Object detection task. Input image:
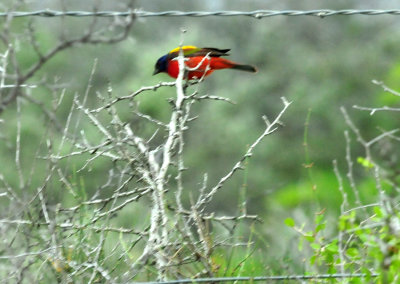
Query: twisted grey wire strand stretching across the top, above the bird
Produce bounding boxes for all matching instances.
[0,9,400,19]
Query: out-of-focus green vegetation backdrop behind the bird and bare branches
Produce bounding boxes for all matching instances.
[0,0,400,276]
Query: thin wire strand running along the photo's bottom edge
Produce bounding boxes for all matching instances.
[135,273,378,284]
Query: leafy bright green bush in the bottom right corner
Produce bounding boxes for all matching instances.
[285,202,400,283]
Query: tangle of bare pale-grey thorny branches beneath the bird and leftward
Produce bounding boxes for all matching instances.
[0,10,290,283]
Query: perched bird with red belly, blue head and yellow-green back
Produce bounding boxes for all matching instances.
[153,45,257,80]
